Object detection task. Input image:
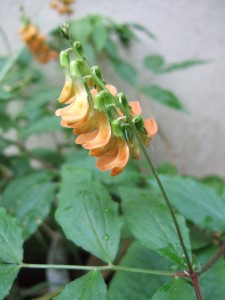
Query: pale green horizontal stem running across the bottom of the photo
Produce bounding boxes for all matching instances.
[19,263,174,276]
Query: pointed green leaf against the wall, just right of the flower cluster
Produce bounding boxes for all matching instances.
[141,85,184,111]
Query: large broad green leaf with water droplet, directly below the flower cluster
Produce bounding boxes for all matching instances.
[56,166,122,262]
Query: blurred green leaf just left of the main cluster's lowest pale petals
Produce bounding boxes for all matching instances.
[20,116,61,138]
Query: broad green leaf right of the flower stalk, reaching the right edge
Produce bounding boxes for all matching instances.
[150,176,225,232]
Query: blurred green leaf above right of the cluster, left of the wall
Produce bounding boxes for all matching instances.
[110,57,137,85]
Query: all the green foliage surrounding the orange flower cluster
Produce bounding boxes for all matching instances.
[0,6,221,300]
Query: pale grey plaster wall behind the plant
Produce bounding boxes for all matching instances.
[0,0,225,176]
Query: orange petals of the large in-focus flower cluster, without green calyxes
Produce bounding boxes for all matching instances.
[56,69,157,176]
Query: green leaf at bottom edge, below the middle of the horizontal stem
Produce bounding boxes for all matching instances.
[53,271,107,300]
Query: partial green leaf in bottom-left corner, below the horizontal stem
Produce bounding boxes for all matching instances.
[0,263,19,299]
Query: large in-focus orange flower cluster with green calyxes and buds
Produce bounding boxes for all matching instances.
[56,44,157,176]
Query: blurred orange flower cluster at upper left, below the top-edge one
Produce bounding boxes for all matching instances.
[19,22,58,63]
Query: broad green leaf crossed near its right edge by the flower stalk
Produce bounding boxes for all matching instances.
[120,188,191,266]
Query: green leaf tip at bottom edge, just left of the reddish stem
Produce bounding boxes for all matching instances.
[151,278,195,300]
